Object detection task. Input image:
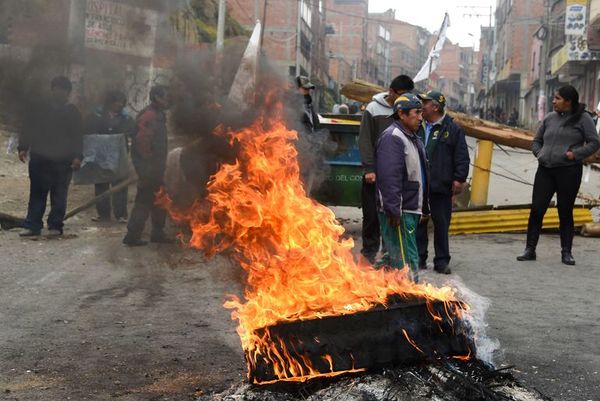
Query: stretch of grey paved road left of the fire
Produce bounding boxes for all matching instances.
[0,224,245,401]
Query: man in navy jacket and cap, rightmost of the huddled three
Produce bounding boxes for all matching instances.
[417,90,470,274]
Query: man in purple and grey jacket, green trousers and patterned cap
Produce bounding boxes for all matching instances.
[375,93,429,282]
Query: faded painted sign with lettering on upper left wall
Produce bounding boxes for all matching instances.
[85,0,158,58]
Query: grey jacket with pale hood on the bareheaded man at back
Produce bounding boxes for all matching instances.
[358,92,394,173]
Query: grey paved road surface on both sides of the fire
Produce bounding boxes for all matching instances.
[0,133,600,401]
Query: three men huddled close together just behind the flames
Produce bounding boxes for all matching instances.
[359,75,470,281]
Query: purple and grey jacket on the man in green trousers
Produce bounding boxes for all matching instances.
[375,120,429,217]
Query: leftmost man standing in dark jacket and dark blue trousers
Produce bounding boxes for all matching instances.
[18,77,82,237]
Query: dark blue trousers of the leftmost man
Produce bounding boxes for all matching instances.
[25,156,73,232]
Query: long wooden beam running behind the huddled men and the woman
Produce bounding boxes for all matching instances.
[340,80,600,163]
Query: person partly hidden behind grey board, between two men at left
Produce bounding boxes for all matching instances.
[84,90,134,223]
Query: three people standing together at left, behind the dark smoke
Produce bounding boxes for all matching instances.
[18,76,173,246]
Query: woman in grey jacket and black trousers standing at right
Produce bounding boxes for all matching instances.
[517,85,600,265]
